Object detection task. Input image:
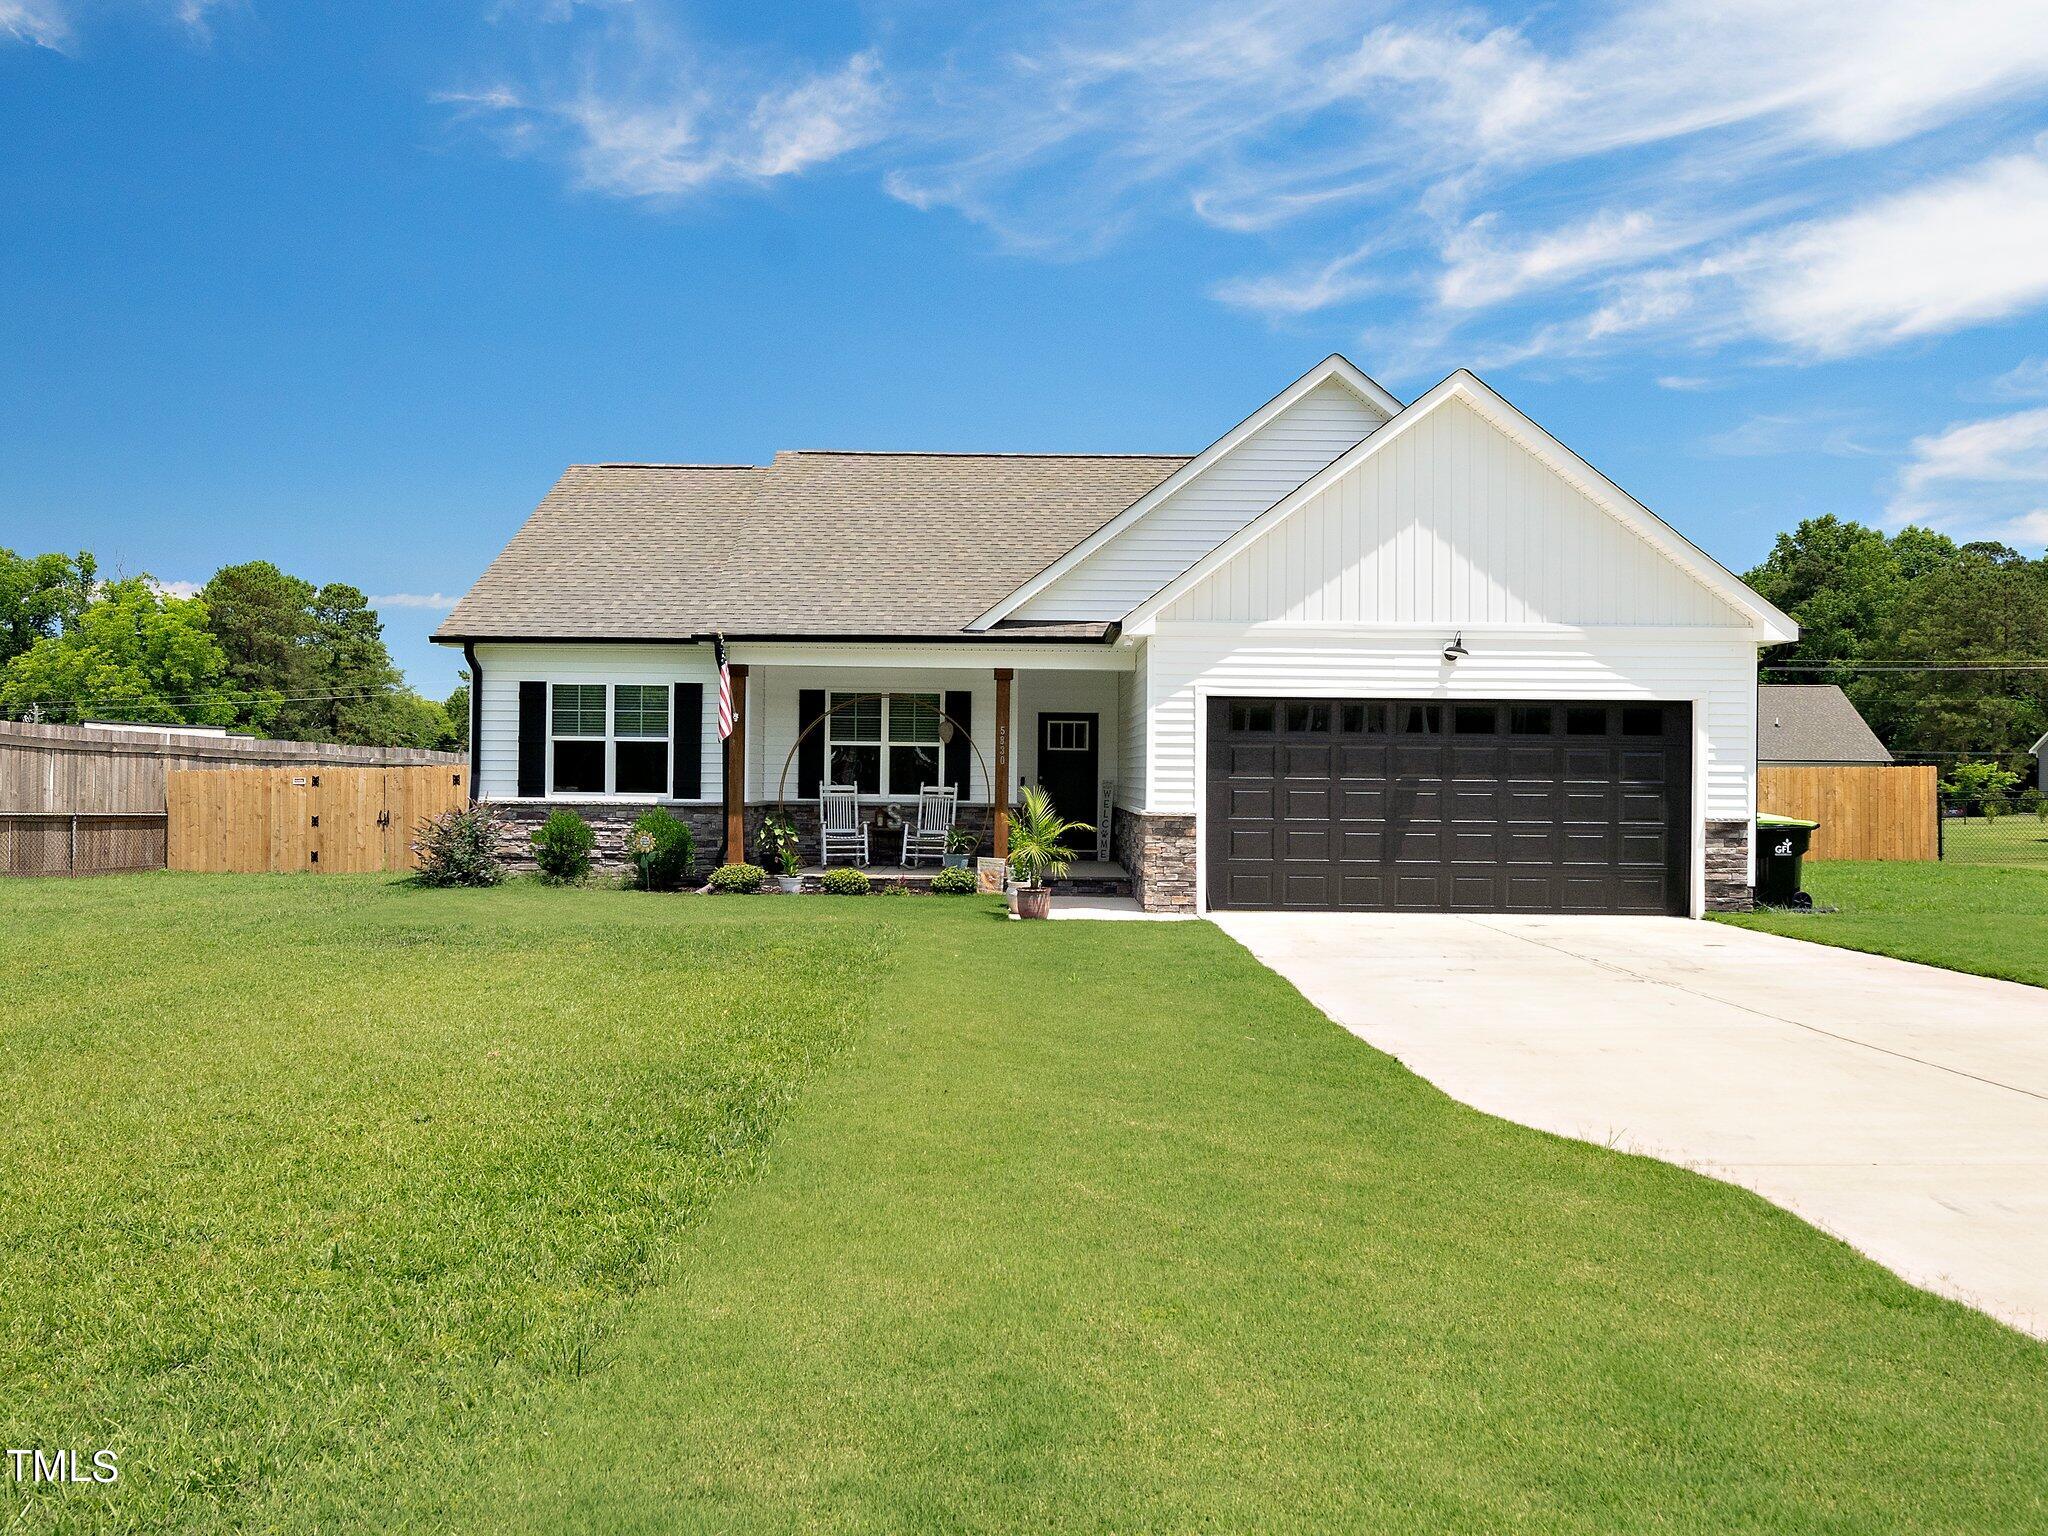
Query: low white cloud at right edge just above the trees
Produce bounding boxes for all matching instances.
[1886,408,2048,547]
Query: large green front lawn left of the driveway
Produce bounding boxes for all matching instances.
[0,877,2048,1534]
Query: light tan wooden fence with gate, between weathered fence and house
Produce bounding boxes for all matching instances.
[166,768,469,874]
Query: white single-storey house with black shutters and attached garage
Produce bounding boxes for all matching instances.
[436,356,1798,913]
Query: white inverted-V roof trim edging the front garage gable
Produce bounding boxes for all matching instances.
[1124,369,1798,643]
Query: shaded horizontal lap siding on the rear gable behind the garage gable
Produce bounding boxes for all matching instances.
[1014,381,1386,623]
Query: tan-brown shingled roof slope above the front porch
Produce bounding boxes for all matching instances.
[436,451,1188,641]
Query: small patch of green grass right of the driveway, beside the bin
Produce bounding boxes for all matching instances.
[1720,860,2048,987]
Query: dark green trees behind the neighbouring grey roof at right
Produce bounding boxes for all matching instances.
[1745,516,2048,778]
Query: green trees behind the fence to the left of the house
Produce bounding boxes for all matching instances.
[0,549,469,748]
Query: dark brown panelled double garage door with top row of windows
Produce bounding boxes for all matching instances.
[1206,698,1692,913]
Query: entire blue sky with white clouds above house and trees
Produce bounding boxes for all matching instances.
[0,0,2048,692]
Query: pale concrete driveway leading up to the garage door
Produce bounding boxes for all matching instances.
[1217,913,2048,1337]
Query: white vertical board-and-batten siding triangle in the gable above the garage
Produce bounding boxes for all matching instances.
[1161,401,1747,639]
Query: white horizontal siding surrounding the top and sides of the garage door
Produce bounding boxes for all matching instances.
[1145,629,1757,825]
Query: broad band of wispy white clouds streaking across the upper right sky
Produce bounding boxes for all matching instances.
[452,0,2048,362]
